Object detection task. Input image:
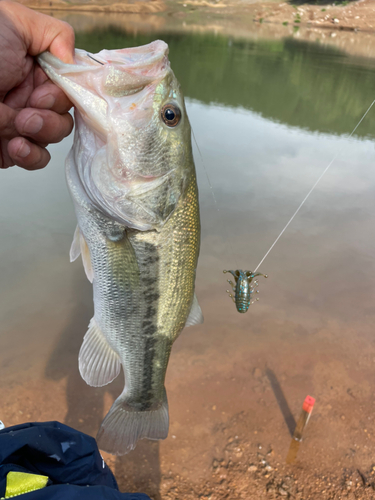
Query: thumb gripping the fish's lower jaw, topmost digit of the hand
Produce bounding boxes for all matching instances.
[1,0,74,64]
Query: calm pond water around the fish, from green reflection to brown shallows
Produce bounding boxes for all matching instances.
[0,16,375,499]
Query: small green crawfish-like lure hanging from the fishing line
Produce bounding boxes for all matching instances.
[223,269,267,313]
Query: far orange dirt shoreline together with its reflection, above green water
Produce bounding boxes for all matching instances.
[17,0,375,58]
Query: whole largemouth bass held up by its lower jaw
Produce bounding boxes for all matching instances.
[39,41,203,455]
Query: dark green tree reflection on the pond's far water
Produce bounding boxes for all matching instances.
[76,28,375,137]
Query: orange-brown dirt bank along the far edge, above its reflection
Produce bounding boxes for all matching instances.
[21,0,375,31]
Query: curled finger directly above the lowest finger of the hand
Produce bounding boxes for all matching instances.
[15,108,73,144]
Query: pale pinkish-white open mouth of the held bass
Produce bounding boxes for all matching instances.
[38,40,170,133]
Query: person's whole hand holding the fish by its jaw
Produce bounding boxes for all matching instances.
[0,0,74,170]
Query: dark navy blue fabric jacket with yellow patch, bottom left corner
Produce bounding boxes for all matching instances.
[0,422,150,500]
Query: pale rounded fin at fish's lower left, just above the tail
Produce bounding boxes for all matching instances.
[78,318,121,387]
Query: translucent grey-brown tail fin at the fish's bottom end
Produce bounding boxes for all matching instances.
[96,389,169,455]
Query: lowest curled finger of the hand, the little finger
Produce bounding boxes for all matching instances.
[8,137,51,170]
